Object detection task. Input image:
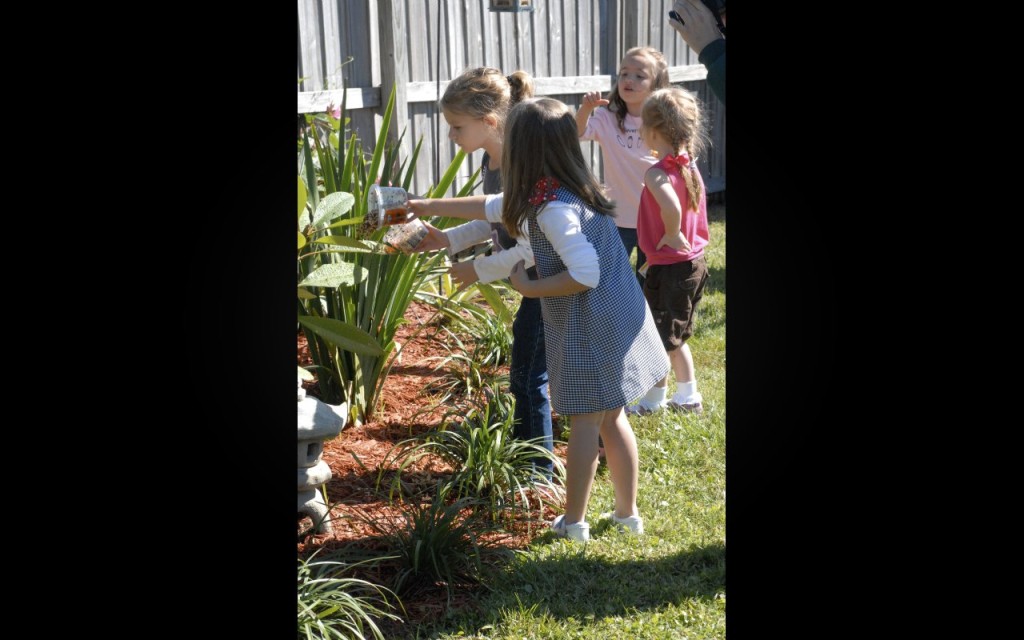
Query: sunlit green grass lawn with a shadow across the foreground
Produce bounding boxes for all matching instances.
[415,205,725,640]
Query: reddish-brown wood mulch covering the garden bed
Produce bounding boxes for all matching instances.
[297,301,565,625]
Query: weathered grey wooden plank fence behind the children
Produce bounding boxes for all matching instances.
[298,0,725,194]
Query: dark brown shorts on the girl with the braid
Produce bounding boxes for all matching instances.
[643,256,708,351]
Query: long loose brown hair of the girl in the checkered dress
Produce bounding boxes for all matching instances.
[502,97,615,237]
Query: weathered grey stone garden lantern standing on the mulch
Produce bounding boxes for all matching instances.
[298,378,348,534]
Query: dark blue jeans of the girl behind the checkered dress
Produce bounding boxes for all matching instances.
[509,298,554,477]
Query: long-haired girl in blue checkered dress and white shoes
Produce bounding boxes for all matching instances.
[503,98,669,541]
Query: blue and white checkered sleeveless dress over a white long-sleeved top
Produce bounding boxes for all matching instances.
[529,187,670,416]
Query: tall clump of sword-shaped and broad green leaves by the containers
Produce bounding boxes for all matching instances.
[298,80,475,420]
